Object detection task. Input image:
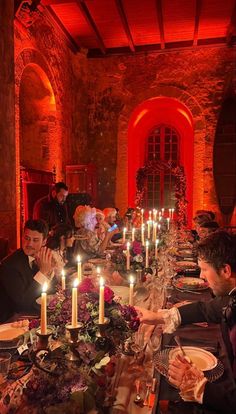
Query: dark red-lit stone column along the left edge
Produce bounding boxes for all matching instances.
[0,0,16,247]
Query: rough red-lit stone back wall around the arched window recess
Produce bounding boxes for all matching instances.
[88,47,236,223]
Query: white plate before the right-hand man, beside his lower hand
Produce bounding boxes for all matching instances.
[169,346,217,371]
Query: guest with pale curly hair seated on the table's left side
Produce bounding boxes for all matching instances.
[73,206,117,255]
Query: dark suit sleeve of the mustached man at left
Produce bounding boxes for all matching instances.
[0,264,41,312]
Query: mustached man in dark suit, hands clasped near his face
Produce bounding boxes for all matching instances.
[0,220,53,322]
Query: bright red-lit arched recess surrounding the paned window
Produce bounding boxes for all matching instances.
[128,97,193,221]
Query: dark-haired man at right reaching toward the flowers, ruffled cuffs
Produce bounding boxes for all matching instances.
[137,231,236,413]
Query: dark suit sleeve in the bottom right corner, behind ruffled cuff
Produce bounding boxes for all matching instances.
[203,382,236,414]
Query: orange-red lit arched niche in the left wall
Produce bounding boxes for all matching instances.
[19,63,62,226]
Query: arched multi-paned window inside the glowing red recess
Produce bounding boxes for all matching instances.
[145,125,180,208]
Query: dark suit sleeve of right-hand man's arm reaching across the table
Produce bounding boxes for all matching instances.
[179,296,229,325]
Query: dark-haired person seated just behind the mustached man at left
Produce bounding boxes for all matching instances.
[46,224,75,276]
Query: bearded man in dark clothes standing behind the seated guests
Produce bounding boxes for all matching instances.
[33,181,70,230]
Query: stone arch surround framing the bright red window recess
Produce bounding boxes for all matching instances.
[116,86,206,223]
